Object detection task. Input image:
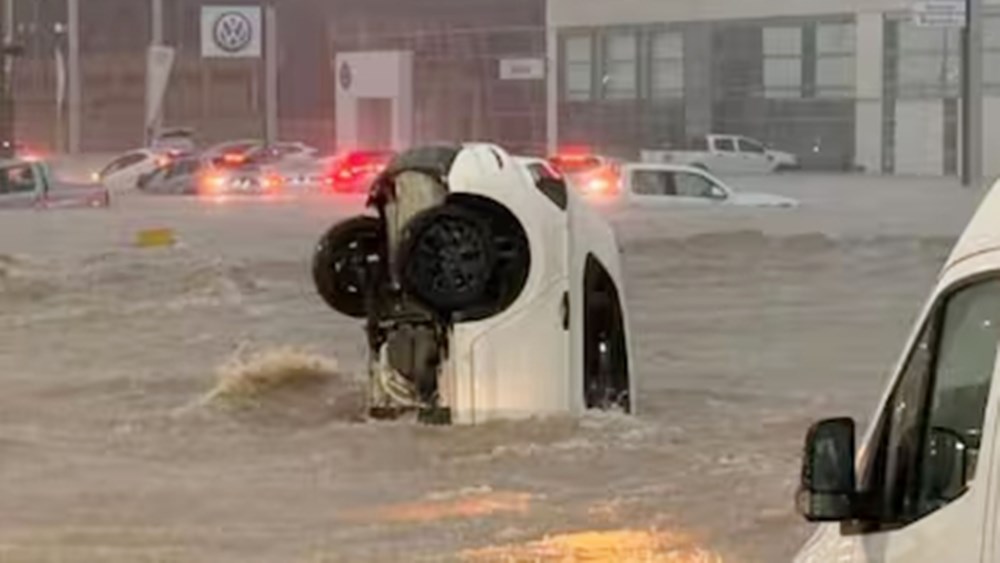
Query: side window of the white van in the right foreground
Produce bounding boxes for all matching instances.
[861,279,1000,528]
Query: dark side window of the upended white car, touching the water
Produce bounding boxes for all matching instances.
[583,254,632,412]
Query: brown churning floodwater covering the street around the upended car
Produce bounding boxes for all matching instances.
[0,175,980,563]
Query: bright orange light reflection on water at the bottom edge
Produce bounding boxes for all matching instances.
[462,530,723,563]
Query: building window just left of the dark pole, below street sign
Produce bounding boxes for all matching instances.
[896,22,960,98]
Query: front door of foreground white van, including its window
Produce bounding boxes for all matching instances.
[828,274,1000,563]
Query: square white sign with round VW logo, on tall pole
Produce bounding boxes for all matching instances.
[201,6,263,58]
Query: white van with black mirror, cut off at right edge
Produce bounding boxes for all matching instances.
[796,186,1000,563]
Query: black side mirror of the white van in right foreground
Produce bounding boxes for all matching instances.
[796,418,857,522]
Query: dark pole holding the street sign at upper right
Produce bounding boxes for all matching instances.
[962,0,983,186]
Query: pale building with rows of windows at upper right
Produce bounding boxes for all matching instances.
[546,0,1000,175]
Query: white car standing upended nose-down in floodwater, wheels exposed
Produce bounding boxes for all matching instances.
[313,144,635,424]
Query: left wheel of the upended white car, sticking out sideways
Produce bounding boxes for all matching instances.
[312,216,382,318]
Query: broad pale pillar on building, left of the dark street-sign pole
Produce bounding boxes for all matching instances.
[854,12,884,173]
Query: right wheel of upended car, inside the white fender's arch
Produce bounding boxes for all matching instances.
[397,204,497,316]
